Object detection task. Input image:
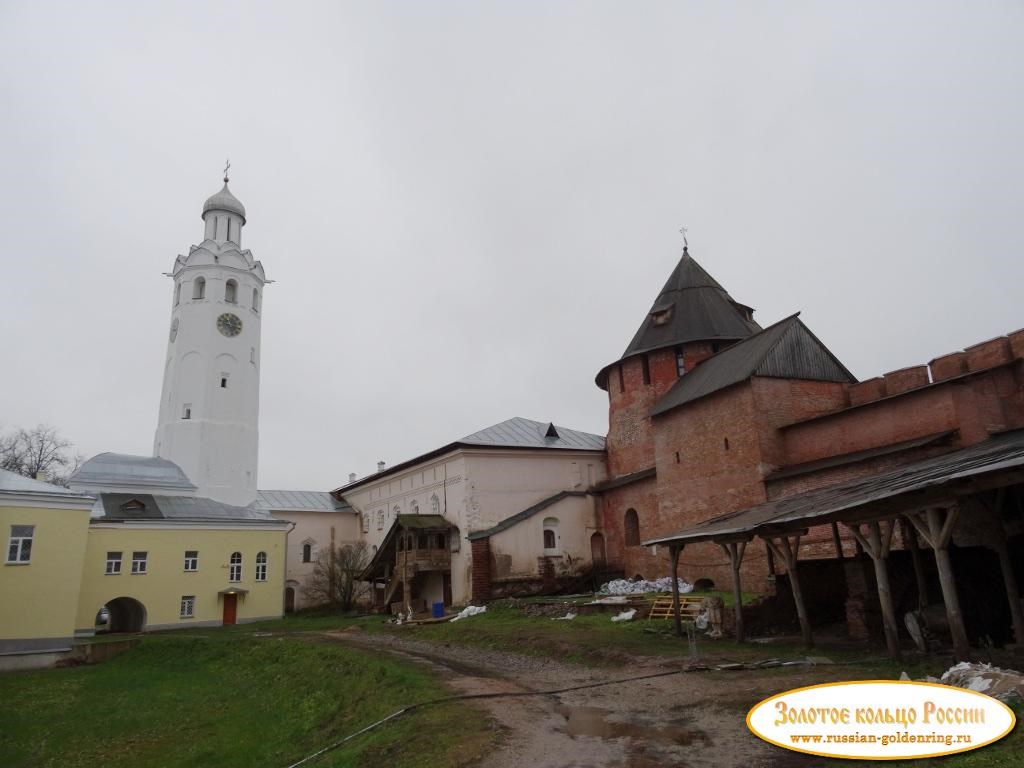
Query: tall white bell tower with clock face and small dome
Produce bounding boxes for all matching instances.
[154,174,267,506]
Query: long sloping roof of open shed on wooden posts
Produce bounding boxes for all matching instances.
[644,429,1024,545]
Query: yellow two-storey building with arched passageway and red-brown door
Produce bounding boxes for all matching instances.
[75,494,289,636]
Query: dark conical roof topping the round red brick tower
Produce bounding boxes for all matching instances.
[596,248,761,389]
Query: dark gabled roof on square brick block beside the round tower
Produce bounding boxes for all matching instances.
[651,314,856,416]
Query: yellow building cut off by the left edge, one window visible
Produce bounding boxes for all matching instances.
[0,470,94,669]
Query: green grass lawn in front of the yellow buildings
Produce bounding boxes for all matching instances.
[0,623,493,768]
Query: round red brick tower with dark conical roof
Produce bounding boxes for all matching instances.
[596,248,761,575]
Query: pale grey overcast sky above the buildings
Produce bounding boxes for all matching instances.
[0,0,1024,488]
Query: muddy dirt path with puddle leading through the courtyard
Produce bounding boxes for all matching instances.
[329,632,822,768]
